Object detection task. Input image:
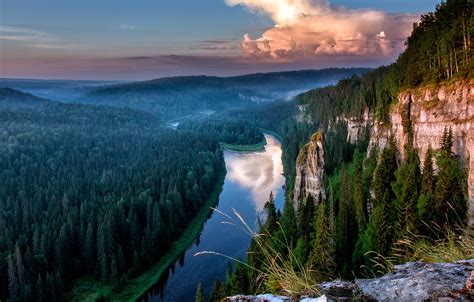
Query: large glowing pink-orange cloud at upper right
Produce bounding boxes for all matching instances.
[226,0,418,61]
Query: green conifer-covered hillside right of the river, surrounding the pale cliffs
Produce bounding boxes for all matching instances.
[220,0,474,296]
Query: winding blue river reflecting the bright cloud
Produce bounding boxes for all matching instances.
[144,134,285,302]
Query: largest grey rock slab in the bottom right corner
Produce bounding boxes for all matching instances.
[356,260,474,302]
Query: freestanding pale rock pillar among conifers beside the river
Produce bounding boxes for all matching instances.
[294,132,326,203]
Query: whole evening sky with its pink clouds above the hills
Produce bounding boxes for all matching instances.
[0,0,439,80]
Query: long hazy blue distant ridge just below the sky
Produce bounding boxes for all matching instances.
[76,68,368,119]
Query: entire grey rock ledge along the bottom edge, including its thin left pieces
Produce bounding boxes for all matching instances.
[225,259,474,302]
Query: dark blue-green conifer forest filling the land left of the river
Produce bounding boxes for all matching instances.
[0,89,230,301]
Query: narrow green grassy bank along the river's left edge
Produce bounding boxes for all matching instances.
[67,171,226,301]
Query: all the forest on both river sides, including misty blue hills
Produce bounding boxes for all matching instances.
[0,0,474,302]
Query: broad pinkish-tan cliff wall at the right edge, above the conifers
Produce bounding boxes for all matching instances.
[344,80,474,225]
